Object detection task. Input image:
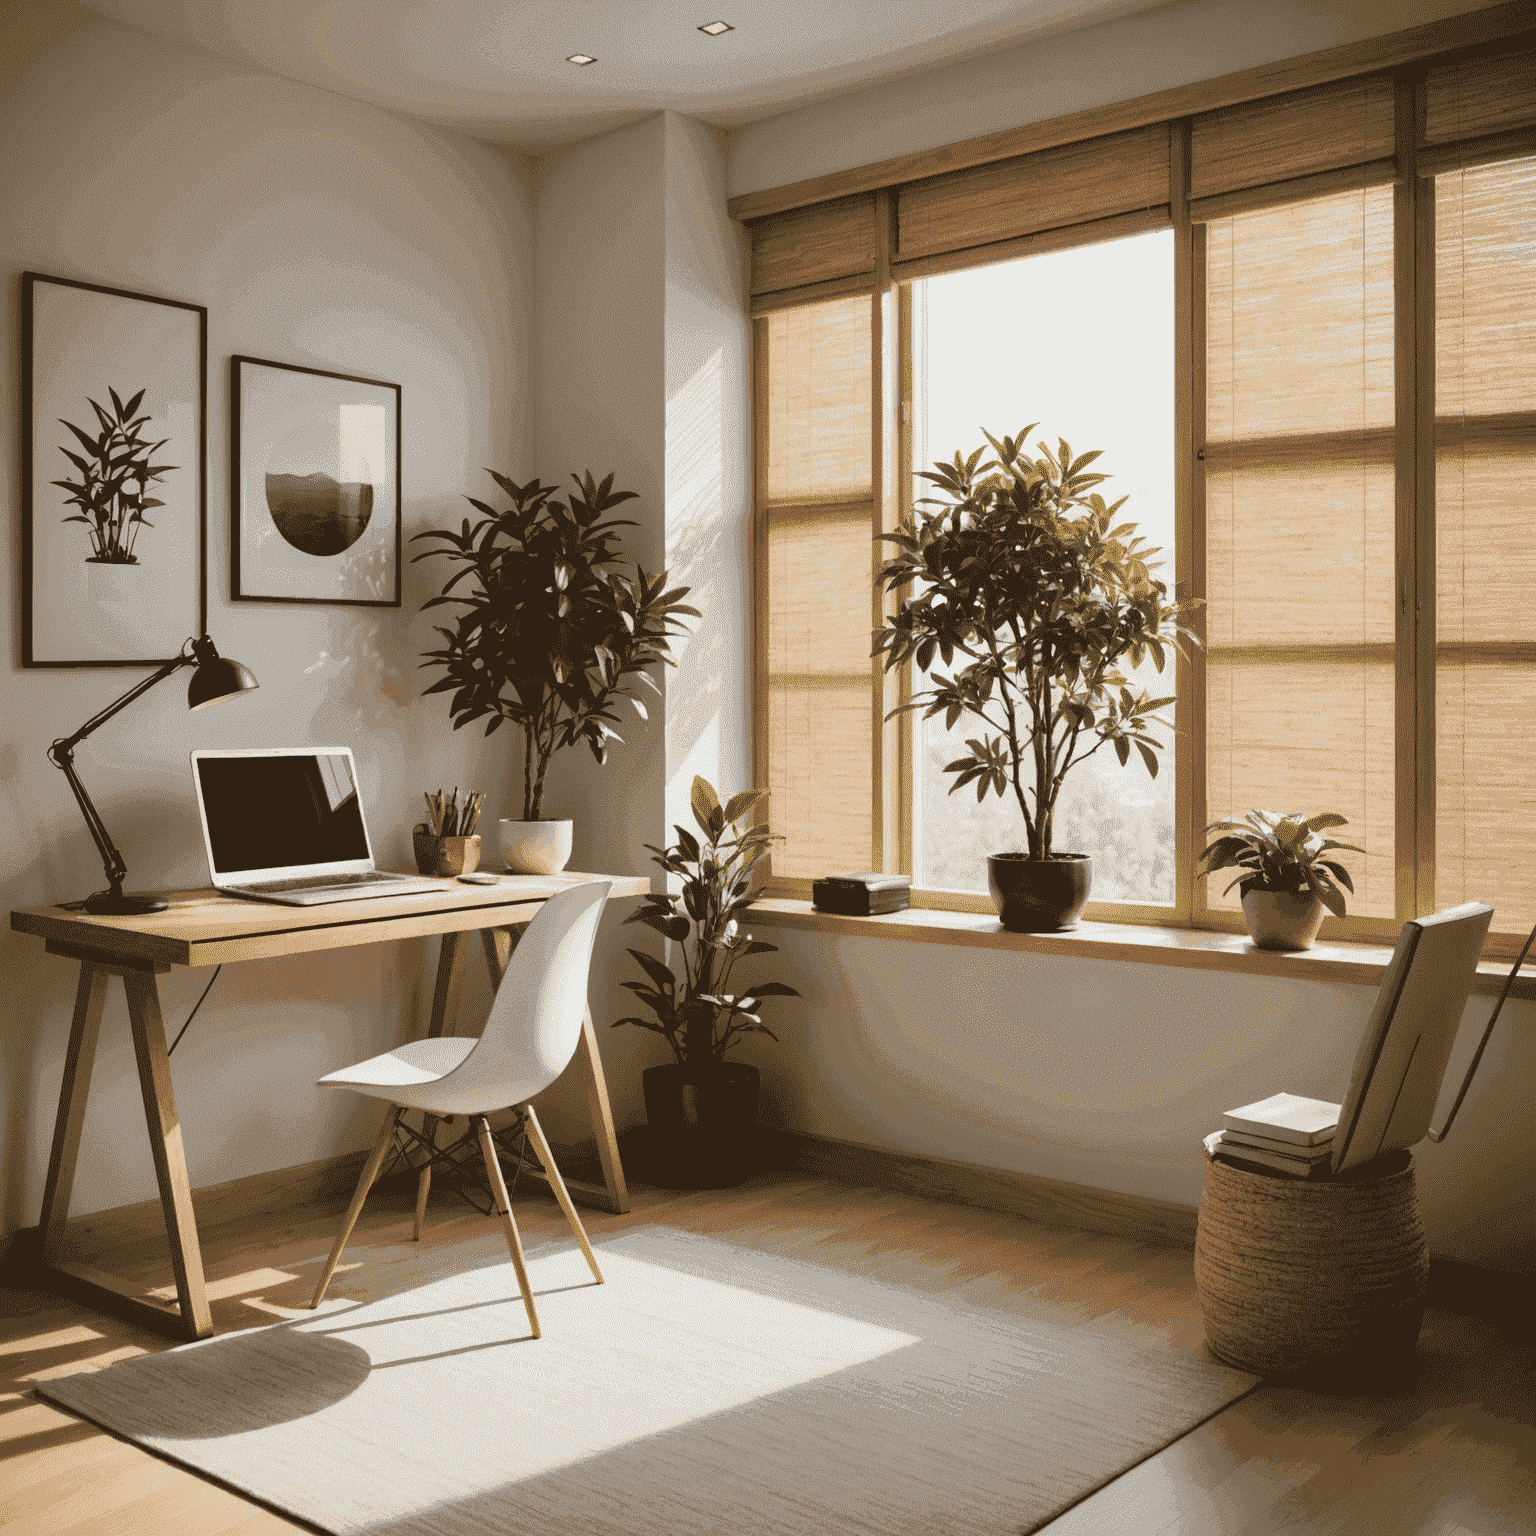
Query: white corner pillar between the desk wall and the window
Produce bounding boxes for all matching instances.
[535,112,751,1141]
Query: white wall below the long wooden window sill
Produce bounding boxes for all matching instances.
[762,928,1536,1270]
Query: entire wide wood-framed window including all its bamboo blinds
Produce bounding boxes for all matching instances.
[753,24,1536,952]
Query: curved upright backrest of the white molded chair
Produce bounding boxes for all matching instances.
[441,880,611,1114]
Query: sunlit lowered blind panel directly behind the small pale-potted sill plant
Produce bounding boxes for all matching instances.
[1204,187,1395,919]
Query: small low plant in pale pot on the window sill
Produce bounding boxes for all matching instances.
[1198,811,1366,949]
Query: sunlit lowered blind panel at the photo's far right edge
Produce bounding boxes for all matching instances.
[1435,158,1536,932]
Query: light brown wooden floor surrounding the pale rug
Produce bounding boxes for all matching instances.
[0,1174,1536,1536]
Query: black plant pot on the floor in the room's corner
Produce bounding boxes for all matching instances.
[641,1061,759,1189]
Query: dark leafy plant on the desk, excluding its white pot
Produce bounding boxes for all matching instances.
[413,470,699,822]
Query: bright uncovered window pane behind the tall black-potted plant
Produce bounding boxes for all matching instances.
[911,230,1175,906]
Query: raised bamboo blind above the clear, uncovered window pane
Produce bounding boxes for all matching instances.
[894,123,1170,278]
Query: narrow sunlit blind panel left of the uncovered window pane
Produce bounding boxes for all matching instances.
[765,298,874,879]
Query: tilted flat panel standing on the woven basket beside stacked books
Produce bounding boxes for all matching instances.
[1333,902,1493,1174]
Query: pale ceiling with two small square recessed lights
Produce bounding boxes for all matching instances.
[84,0,1163,154]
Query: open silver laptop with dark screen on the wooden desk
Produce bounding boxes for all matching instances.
[192,746,452,906]
